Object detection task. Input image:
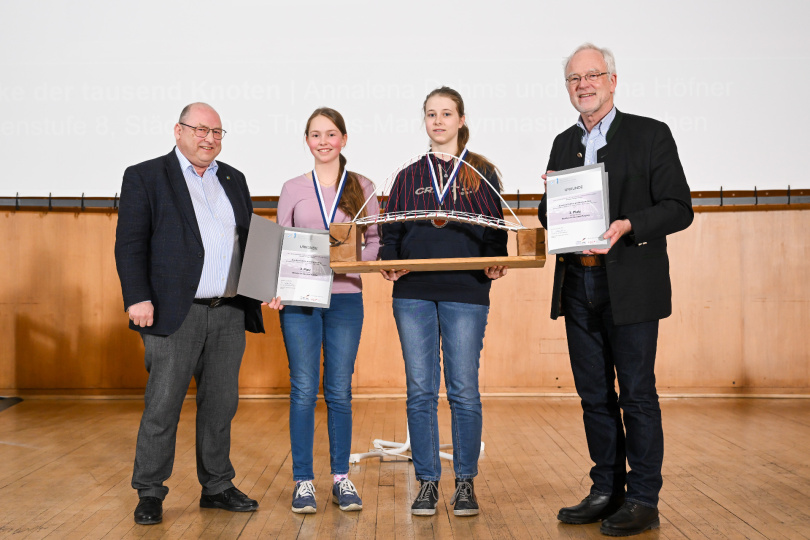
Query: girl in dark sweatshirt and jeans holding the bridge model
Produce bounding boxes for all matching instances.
[380,87,507,516]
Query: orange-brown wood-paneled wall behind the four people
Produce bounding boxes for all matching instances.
[0,210,810,394]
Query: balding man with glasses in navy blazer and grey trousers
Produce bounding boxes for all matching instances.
[115,103,264,525]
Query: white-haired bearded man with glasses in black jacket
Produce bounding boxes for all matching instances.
[538,43,693,536]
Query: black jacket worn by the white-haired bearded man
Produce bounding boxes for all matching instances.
[538,110,694,324]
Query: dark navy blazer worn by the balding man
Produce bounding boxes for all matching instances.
[115,150,264,336]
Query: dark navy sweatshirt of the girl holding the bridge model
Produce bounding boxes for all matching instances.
[380,156,507,306]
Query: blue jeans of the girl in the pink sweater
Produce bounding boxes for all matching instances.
[279,293,363,481]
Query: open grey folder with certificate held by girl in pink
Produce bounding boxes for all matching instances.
[237,214,333,308]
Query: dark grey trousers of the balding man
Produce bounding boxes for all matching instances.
[132,304,245,499]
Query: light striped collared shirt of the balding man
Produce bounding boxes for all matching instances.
[174,147,241,298]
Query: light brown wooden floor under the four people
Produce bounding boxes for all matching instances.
[0,398,810,539]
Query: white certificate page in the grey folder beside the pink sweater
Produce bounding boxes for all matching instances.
[276,228,332,307]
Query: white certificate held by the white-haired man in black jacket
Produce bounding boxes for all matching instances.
[546,163,610,253]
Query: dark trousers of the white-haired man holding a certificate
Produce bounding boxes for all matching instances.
[562,264,664,507]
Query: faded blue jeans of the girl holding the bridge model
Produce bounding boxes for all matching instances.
[394,298,489,480]
